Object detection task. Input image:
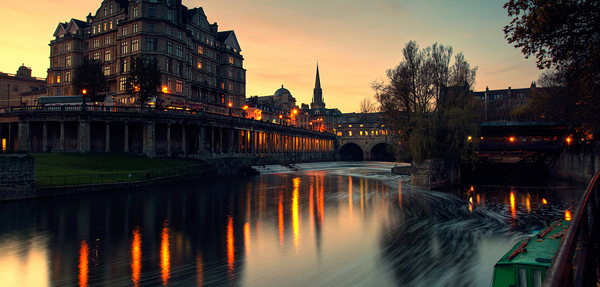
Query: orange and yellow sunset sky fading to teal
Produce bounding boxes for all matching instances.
[0,0,541,113]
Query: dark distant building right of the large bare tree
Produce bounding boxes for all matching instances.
[475,83,536,121]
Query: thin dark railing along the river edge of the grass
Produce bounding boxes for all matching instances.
[36,164,209,188]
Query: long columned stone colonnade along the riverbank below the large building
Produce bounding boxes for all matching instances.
[0,106,336,162]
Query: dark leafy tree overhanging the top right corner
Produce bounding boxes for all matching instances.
[504,0,600,131]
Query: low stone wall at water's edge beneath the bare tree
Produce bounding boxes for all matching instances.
[410,159,460,189]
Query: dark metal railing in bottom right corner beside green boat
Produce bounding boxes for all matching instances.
[543,172,600,287]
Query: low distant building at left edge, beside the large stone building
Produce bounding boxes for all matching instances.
[0,65,46,108]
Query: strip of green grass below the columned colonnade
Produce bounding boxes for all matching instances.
[31,153,208,176]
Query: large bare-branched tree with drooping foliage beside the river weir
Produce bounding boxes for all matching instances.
[372,41,478,163]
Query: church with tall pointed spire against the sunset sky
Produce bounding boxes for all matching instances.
[298,64,342,133]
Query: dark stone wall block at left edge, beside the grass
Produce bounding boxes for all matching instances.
[0,154,35,201]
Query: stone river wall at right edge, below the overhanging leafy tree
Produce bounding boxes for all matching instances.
[548,152,600,184]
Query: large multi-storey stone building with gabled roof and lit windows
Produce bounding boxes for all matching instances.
[48,0,246,113]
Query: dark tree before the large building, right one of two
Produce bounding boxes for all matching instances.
[125,56,161,107]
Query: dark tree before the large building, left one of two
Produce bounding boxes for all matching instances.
[73,58,108,102]
